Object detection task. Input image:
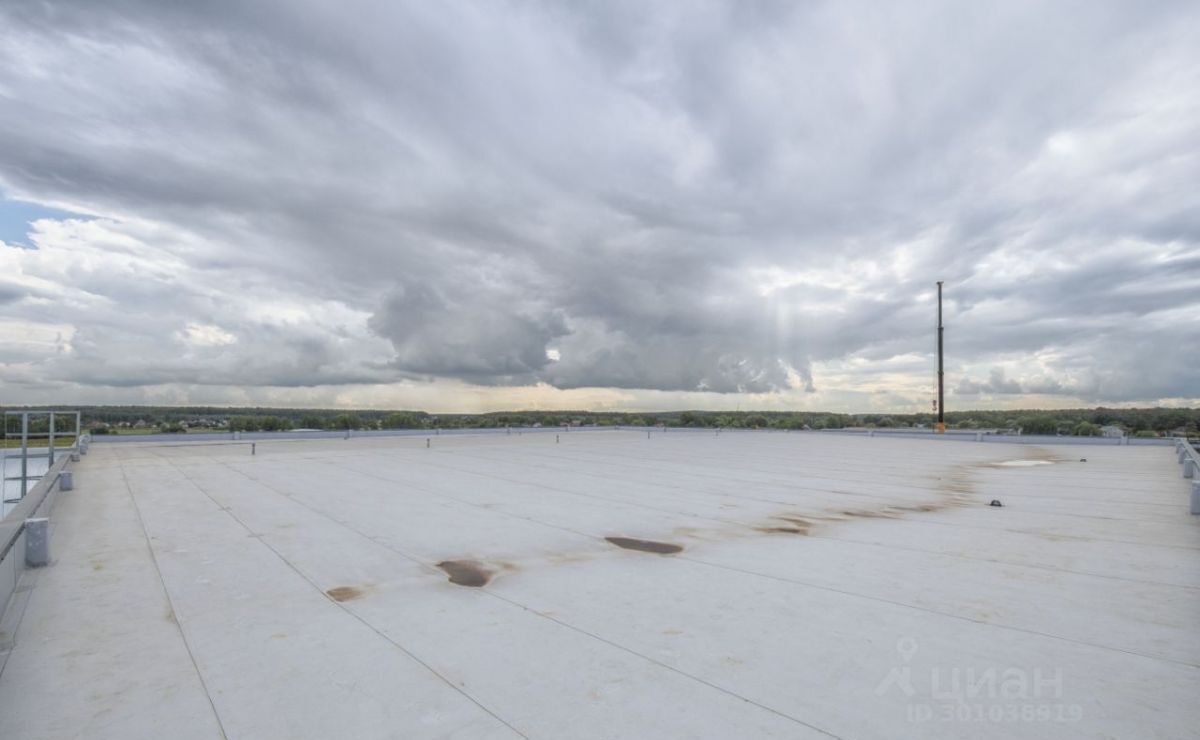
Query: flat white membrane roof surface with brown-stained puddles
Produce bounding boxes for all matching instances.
[0,431,1200,740]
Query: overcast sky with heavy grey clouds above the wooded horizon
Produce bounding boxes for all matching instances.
[0,0,1200,411]
